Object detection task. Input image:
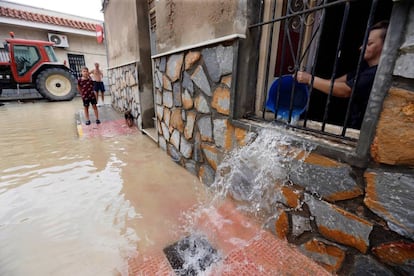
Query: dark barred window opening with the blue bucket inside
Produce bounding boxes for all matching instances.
[250,0,392,141]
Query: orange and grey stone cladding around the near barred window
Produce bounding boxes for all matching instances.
[154,40,414,275]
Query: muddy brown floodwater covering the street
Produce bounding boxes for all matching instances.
[0,98,205,275]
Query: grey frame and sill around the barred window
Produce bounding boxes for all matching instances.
[230,0,407,167]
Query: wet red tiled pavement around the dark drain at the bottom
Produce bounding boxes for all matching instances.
[129,203,331,276]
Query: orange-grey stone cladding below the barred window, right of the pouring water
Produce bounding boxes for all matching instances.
[258,150,414,275]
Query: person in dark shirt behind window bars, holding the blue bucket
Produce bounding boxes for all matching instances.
[296,21,388,129]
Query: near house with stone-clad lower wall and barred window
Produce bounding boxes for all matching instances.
[103,0,414,275]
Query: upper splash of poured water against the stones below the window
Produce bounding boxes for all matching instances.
[211,129,312,215]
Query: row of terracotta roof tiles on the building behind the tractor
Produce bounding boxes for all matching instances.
[0,7,96,32]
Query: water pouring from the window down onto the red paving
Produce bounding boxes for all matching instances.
[167,129,313,275]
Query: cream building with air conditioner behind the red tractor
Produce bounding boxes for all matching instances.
[0,0,107,98]
